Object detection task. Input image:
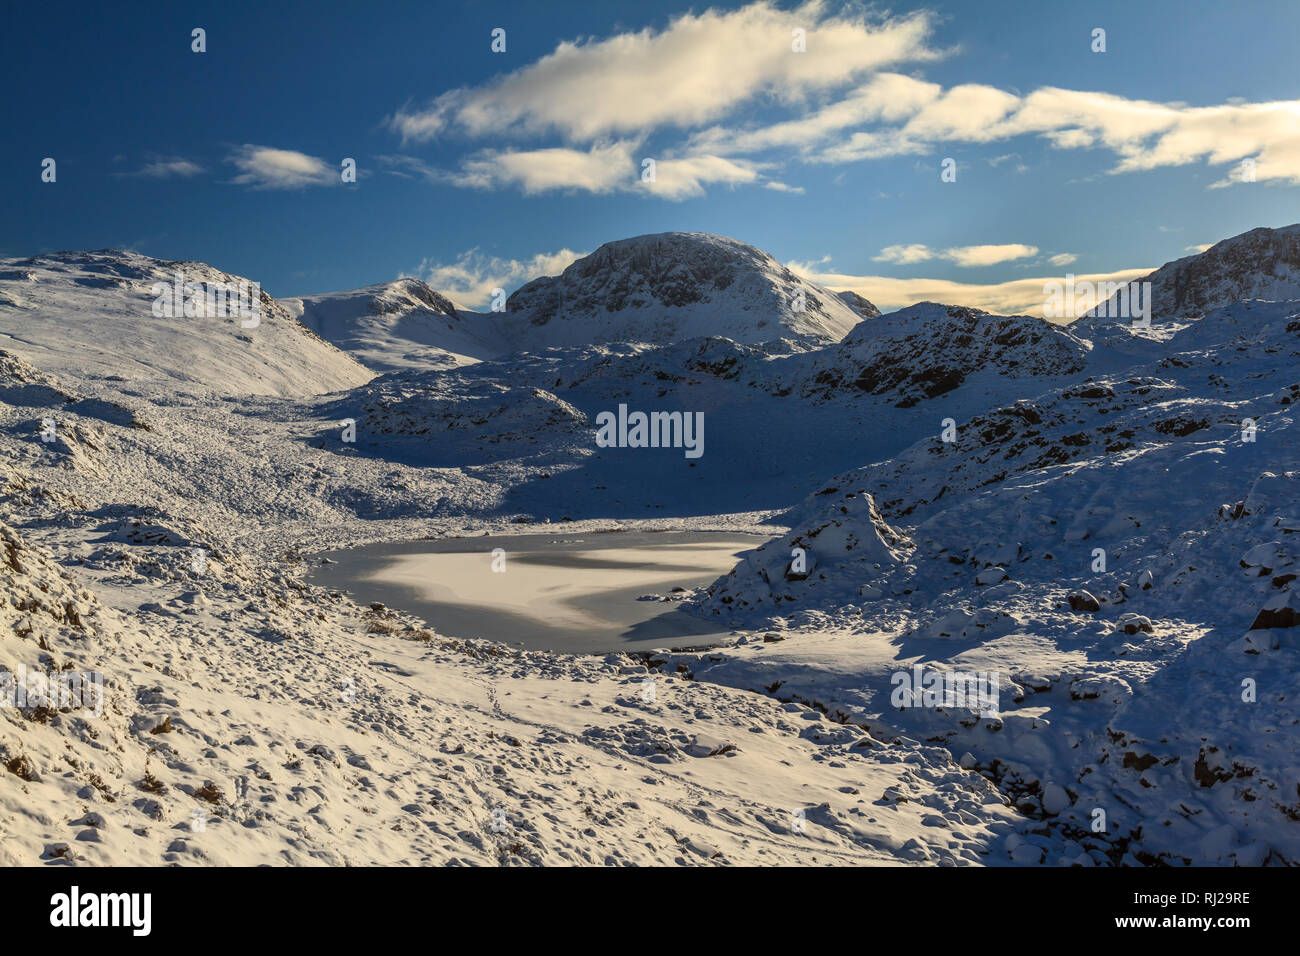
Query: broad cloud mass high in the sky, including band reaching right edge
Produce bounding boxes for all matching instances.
[386,0,1300,199]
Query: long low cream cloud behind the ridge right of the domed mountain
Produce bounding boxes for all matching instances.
[785,261,1152,316]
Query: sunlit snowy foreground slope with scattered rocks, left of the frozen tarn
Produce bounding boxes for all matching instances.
[0,345,1015,866]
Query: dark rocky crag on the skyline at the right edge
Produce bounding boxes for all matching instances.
[1080,224,1300,326]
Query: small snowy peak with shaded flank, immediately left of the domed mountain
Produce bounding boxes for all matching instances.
[280,278,506,372]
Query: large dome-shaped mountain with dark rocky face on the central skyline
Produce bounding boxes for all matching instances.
[504,233,879,349]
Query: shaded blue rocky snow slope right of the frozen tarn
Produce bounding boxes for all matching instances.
[670,302,1300,865]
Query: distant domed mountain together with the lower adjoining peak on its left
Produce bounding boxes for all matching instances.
[293,233,880,372]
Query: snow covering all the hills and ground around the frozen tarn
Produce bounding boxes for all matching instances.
[0,228,1300,866]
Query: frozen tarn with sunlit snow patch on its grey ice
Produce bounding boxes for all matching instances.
[313,532,766,654]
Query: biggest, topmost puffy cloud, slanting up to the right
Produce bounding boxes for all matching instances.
[389,0,936,142]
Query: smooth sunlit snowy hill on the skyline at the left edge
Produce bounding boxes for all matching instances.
[0,250,372,395]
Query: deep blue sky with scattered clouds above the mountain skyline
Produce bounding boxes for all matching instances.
[0,0,1300,311]
